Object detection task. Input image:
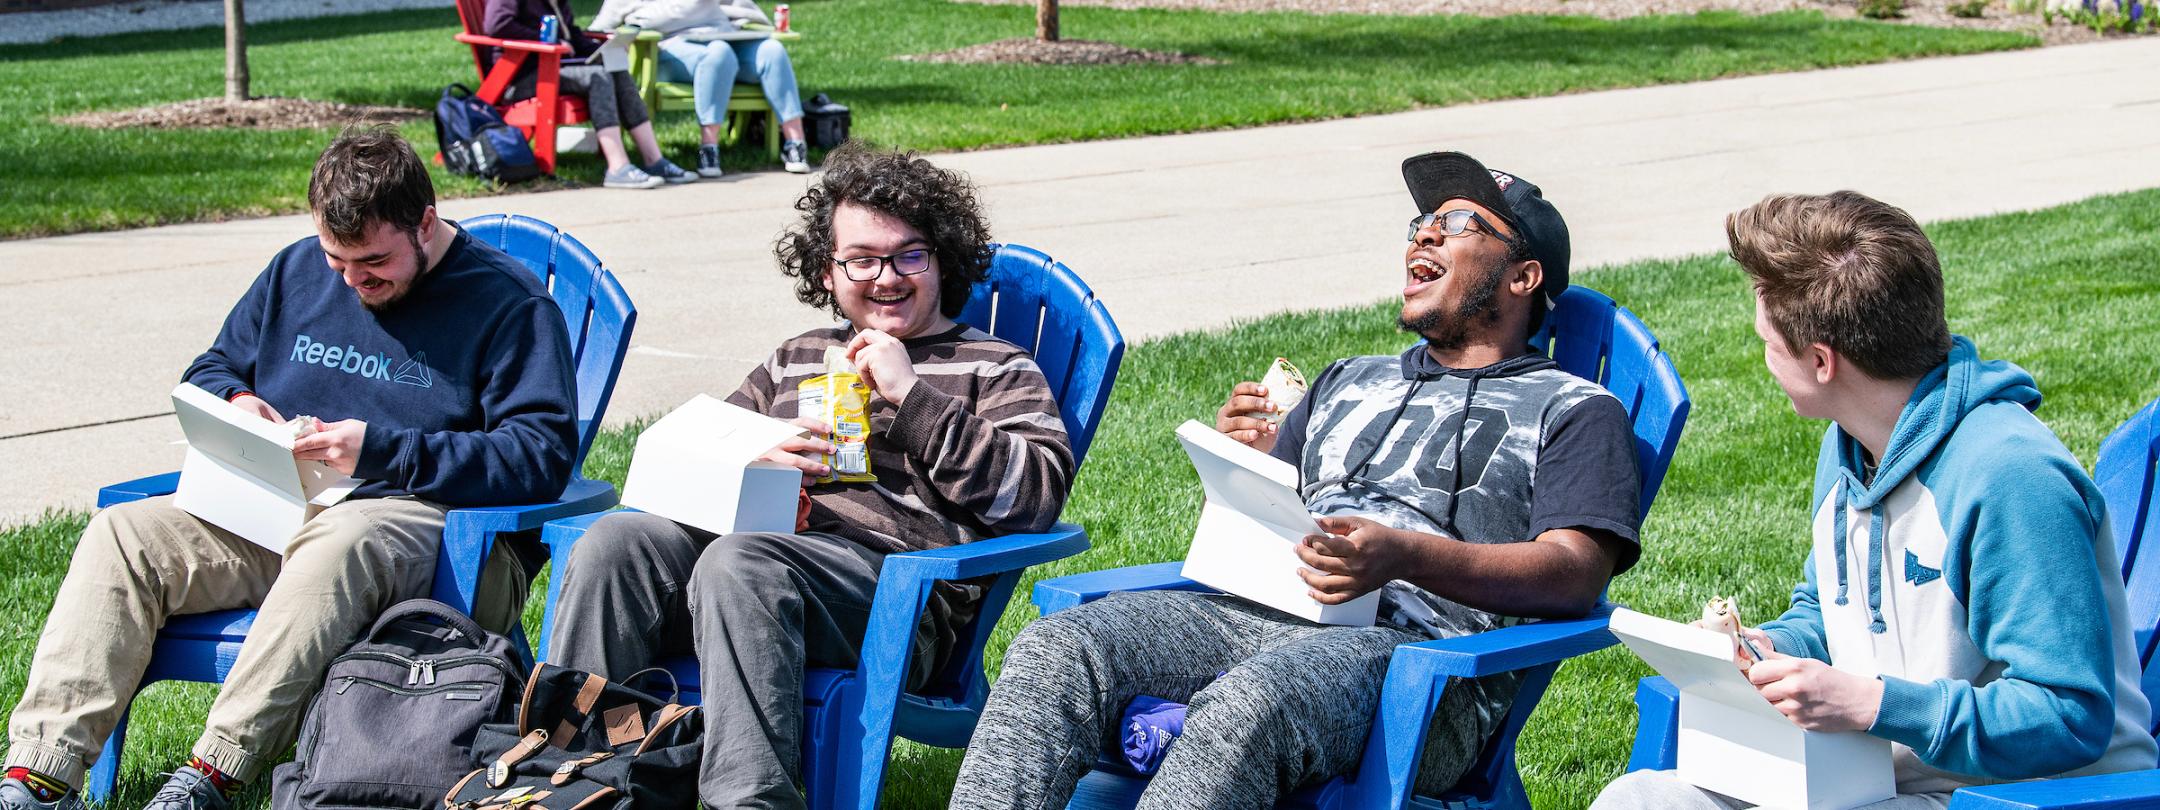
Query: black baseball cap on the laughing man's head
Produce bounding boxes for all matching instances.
[1402,151,1568,302]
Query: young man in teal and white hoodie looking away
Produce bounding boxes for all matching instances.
[1594,192,2156,810]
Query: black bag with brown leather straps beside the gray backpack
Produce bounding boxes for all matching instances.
[443,663,704,810]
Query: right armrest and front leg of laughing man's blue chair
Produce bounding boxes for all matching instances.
[1348,603,1618,808]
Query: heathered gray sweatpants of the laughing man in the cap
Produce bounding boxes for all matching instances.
[953,592,1495,808]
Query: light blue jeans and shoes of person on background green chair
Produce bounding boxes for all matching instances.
[661,37,810,177]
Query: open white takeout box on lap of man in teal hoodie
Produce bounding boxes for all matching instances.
[1611,607,1896,810]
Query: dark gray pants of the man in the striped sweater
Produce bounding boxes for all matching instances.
[549,512,933,808]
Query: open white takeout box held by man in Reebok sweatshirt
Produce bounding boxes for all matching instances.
[173,382,361,553]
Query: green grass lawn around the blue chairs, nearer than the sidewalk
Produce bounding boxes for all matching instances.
[0,190,2160,808]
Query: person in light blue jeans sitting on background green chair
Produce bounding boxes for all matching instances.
[592,0,810,177]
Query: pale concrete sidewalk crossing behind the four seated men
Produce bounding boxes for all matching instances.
[0,39,2160,523]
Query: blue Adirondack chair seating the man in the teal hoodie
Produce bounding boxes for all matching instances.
[1626,400,2160,810]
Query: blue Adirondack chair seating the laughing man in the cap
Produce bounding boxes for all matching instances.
[1035,287,1689,810]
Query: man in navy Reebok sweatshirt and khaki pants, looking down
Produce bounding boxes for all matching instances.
[0,127,577,810]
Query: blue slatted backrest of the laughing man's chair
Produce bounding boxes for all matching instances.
[1449,287,1689,797]
